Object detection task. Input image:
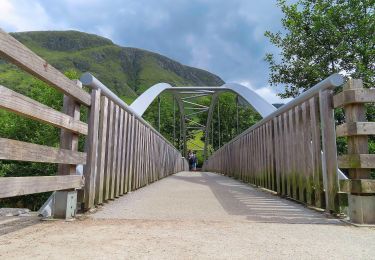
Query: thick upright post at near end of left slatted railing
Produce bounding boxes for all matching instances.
[83,89,100,210]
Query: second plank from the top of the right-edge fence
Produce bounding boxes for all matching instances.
[336,122,375,136]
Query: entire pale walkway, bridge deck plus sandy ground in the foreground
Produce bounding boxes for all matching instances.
[0,172,375,259]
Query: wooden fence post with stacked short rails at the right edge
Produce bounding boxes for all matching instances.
[333,79,375,224]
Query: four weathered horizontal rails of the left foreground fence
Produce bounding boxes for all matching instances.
[0,30,91,198]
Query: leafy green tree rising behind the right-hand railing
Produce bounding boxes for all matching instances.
[265,0,375,97]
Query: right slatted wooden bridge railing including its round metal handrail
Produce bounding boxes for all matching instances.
[203,74,343,212]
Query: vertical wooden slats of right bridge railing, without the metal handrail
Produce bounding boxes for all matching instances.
[204,96,338,212]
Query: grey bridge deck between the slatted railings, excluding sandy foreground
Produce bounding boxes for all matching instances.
[92,172,342,225]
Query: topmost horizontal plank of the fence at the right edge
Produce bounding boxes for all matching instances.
[333,89,375,108]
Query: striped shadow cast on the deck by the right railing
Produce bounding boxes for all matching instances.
[169,172,345,225]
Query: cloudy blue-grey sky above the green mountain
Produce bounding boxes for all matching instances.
[0,0,285,103]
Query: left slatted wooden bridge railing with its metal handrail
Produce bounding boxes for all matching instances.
[81,73,189,208]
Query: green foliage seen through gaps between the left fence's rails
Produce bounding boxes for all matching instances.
[0,67,78,210]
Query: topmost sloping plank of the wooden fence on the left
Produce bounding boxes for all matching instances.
[0,29,91,106]
